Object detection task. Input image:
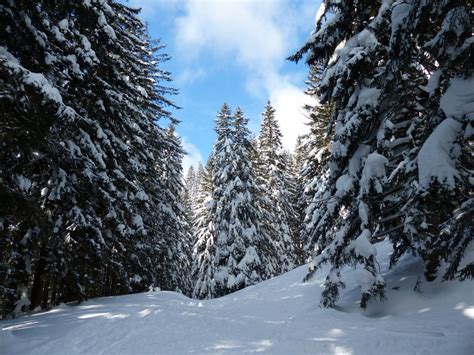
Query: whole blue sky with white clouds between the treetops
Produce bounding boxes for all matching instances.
[127,0,320,169]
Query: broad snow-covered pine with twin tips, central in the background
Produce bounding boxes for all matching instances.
[193,104,280,298]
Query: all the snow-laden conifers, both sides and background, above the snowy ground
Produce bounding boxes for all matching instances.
[0,0,474,316]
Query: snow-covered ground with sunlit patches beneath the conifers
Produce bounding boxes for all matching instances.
[0,244,474,354]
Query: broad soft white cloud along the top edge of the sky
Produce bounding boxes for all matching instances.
[176,0,287,71]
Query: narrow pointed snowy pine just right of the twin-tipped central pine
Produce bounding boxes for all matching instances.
[257,101,297,273]
